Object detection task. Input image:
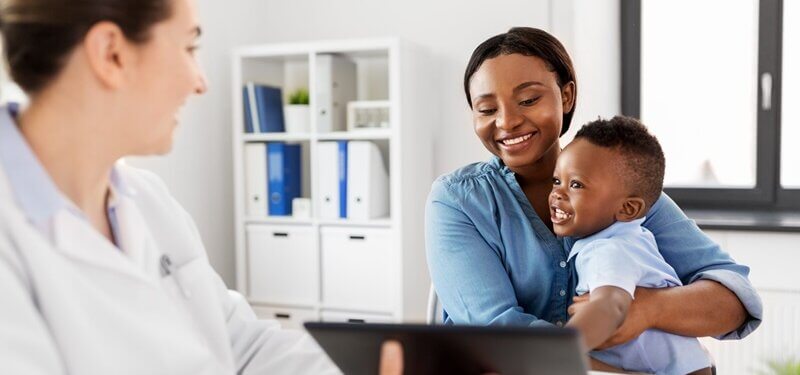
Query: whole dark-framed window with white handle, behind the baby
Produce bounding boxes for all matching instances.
[621,0,800,210]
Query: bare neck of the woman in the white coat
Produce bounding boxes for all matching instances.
[18,98,118,217]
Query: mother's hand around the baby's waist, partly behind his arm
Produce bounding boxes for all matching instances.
[567,288,658,350]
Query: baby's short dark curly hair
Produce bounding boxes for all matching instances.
[575,116,665,209]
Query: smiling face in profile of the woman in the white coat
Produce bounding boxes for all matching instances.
[125,0,206,154]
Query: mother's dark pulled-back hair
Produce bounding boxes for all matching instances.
[464,27,578,135]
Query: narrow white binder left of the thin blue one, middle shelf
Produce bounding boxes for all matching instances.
[317,142,339,219]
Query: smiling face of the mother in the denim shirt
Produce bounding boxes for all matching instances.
[469,54,574,173]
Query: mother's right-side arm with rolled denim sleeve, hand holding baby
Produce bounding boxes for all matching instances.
[570,194,762,347]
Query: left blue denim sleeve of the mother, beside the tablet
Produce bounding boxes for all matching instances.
[425,180,549,326]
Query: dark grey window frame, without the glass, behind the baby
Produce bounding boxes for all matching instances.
[620,0,800,210]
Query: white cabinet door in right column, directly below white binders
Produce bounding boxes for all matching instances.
[320,227,398,313]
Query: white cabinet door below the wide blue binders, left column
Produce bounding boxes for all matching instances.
[247,224,319,306]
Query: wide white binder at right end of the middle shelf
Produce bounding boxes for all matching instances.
[347,141,389,219]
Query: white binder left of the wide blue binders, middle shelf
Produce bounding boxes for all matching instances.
[244,143,267,216]
